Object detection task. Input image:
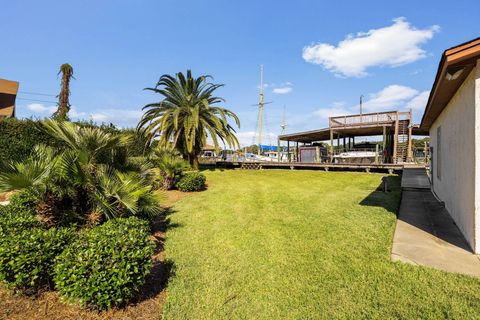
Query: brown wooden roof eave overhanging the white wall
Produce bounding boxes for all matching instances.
[420,38,480,130]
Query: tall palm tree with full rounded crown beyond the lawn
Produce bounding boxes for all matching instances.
[137,70,240,169]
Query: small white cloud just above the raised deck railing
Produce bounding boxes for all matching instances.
[357,84,418,112]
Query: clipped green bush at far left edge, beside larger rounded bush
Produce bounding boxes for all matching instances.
[0,228,75,294]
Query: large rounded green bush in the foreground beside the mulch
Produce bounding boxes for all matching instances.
[54,217,154,309]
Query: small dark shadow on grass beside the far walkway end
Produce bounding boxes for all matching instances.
[360,176,401,215]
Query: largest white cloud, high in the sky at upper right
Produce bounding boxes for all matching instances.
[302,18,440,77]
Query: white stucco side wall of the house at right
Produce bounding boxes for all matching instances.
[430,66,480,253]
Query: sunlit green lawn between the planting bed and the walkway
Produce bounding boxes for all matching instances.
[164,170,480,319]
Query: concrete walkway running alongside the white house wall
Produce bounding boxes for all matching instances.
[391,168,480,277]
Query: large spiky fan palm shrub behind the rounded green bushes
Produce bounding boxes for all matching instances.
[0,120,160,225]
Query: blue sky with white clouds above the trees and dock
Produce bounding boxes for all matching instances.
[0,0,480,144]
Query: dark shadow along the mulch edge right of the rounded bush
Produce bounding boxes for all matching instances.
[132,207,182,303]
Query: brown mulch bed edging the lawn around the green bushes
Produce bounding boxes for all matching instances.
[0,194,191,320]
